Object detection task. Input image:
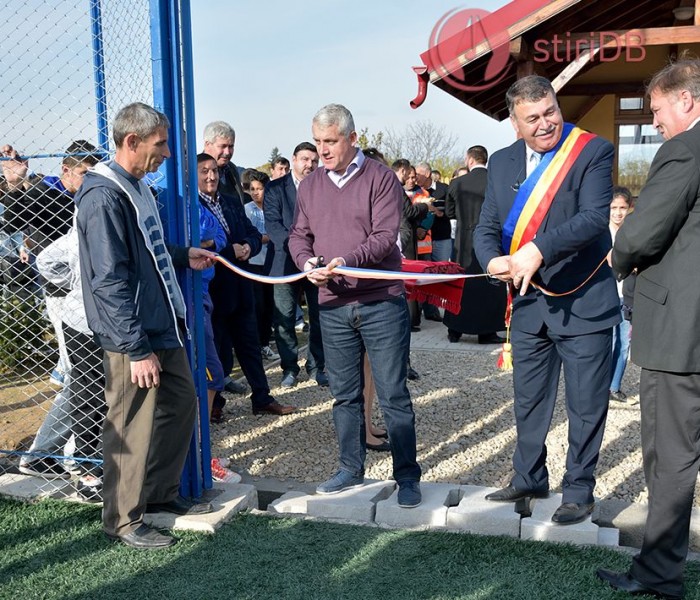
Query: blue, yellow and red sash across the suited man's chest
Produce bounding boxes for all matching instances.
[502,123,596,254]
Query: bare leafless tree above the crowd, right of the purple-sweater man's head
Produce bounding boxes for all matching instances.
[382,121,458,164]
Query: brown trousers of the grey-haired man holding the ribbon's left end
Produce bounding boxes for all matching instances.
[102,348,197,535]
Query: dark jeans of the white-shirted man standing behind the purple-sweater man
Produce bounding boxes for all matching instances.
[273,279,326,375]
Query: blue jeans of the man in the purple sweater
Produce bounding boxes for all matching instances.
[319,296,421,482]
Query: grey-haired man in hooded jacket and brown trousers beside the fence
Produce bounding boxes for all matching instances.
[75,103,214,549]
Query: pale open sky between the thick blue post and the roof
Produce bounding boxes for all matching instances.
[191,0,514,167]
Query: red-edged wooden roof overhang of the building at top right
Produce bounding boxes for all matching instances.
[421,0,700,120]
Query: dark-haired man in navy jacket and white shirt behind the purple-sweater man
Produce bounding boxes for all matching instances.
[263,142,328,387]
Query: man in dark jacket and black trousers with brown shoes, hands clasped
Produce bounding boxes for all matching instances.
[197,152,295,415]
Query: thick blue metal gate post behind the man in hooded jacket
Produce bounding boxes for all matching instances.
[151,0,211,496]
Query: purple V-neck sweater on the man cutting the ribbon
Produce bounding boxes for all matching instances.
[289,159,404,306]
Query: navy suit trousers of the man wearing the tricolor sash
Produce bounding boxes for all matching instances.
[511,327,612,503]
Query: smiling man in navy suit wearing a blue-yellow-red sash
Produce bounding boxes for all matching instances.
[474,75,620,525]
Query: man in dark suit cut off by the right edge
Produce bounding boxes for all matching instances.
[598,60,700,598]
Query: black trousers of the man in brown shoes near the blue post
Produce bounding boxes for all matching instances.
[211,285,273,407]
